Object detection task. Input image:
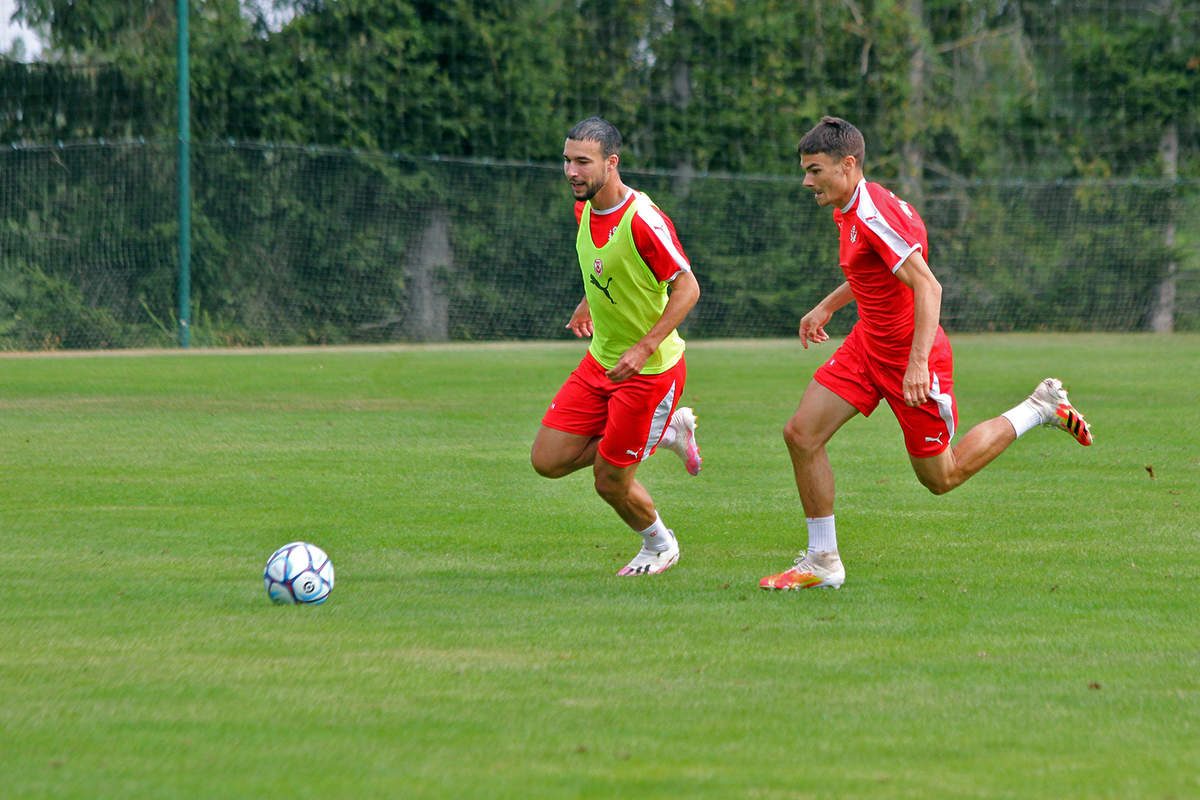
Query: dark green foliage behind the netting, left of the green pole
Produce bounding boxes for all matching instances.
[0,144,174,348]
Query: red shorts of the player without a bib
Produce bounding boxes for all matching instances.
[812,326,959,458]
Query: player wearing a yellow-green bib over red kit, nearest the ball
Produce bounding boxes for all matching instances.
[530,116,702,576]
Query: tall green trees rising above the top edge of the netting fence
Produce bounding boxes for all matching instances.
[9,0,1200,180]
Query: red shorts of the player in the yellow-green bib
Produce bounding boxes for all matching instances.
[541,353,688,467]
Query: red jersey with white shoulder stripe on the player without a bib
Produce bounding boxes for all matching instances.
[833,178,929,365]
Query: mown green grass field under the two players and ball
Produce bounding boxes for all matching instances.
[0,335,1200,799]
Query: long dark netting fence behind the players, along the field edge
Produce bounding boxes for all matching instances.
[0,142,1200,349]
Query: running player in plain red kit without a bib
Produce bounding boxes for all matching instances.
[758,116,1092,589]
